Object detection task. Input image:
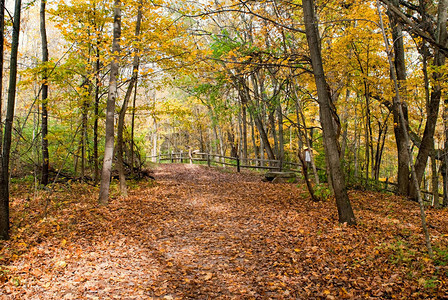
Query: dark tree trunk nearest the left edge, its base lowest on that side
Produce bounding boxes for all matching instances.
[0,0,22,240]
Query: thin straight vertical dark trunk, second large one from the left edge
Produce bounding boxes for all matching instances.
[40,0,50,185]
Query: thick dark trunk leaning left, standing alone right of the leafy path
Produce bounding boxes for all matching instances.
[303,0,356,224]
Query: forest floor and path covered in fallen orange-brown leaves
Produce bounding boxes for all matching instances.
[0,164,448,299]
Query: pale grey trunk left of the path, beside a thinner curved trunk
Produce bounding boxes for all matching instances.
[99,0,121,205]
